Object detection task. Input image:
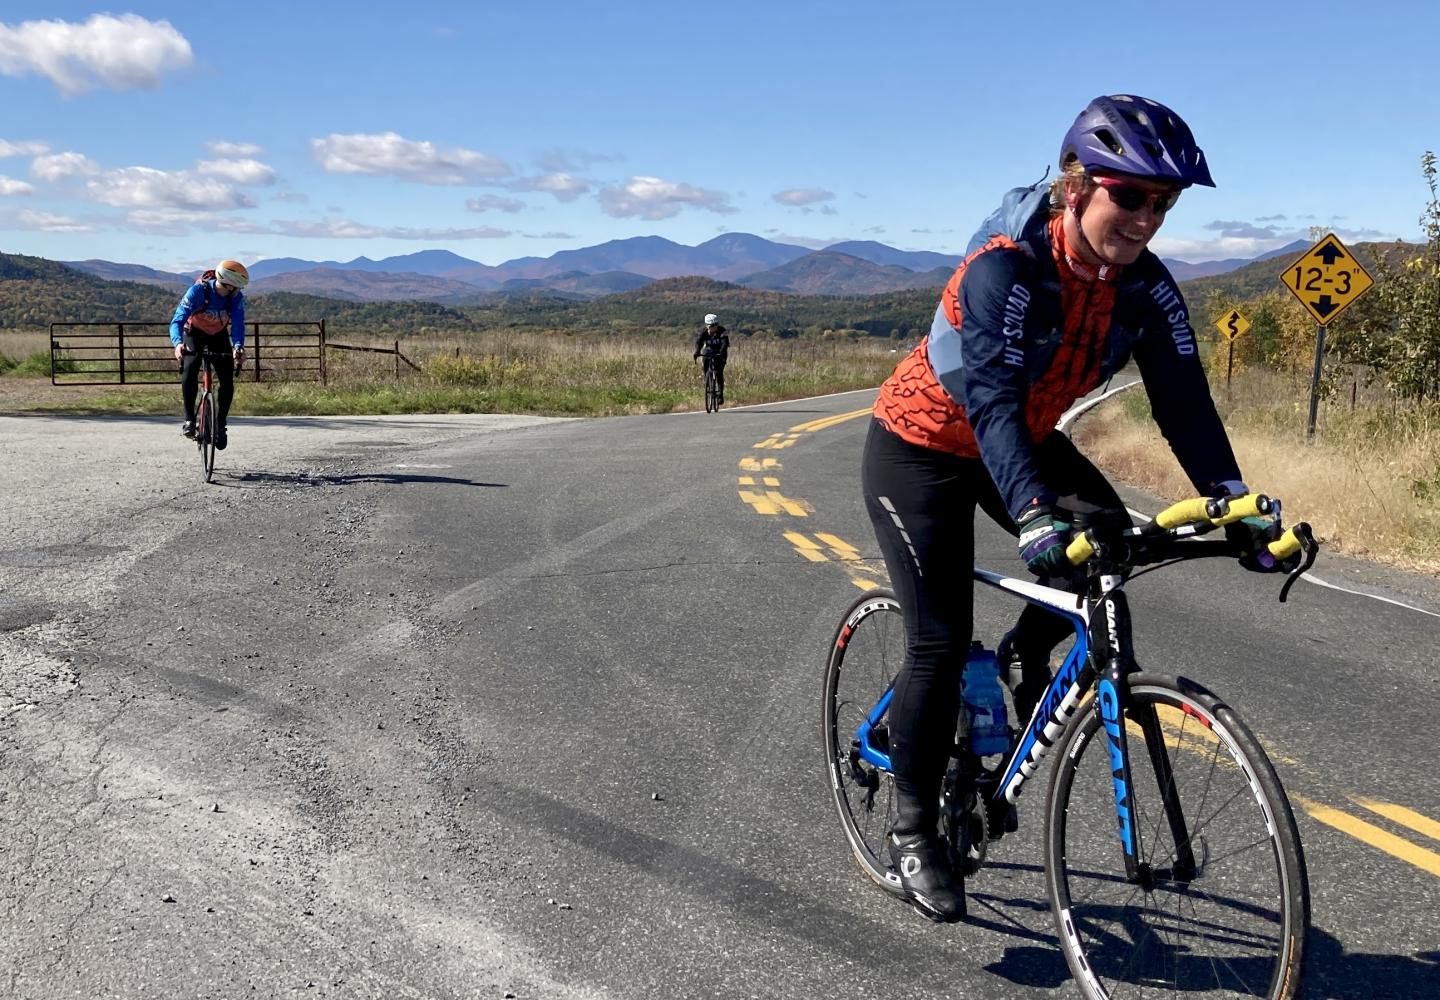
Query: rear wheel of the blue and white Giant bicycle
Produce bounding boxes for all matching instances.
[822,589,904,895]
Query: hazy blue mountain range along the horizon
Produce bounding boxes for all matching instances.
[66,232,1309,305]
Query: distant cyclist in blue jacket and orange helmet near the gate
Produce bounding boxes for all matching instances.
[170,261,251,448]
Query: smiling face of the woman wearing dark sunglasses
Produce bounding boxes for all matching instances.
[1066,177,1178,265]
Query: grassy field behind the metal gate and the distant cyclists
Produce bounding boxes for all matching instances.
[0,331,897,416]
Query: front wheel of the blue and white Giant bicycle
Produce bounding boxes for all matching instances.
[1045,673,1310,1000]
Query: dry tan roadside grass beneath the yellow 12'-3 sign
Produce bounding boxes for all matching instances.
[1076,372,1440,573]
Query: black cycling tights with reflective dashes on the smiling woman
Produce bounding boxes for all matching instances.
[861,422,1123,833]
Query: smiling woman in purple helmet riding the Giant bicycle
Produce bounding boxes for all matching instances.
[861,94,1282,921]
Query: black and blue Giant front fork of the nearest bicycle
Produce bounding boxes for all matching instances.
[1090,588,1197,892]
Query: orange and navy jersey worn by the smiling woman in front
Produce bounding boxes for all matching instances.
[874,182,1240,514]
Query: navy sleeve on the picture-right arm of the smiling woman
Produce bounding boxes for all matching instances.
[1133,259,1240,496]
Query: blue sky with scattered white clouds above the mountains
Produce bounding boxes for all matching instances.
[0,0,1440,269]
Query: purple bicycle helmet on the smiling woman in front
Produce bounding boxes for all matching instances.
[1060,94,1215,187]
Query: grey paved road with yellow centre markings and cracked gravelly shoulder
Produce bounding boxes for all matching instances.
[0,393,1440,1000]
